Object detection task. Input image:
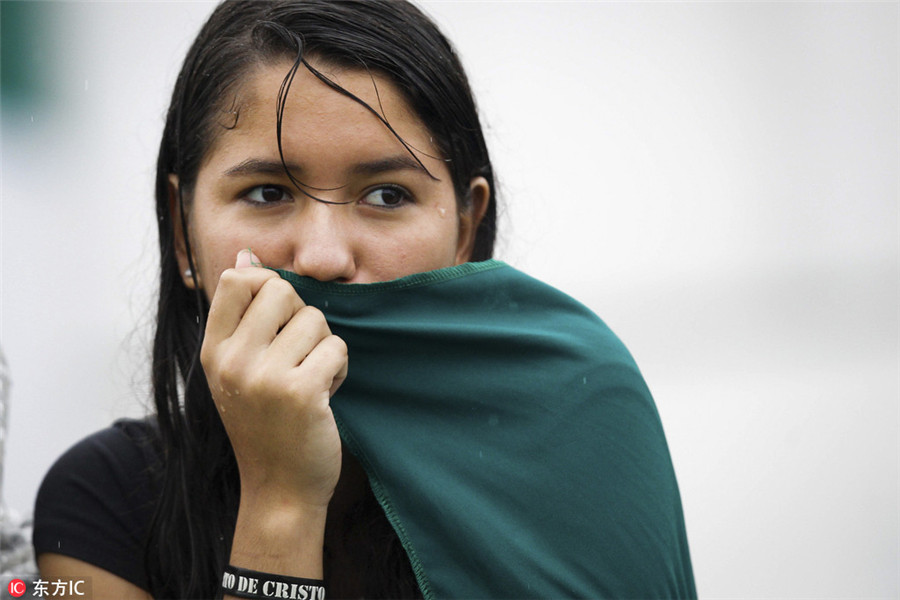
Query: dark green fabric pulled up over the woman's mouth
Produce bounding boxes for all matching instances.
[279,261,696,598]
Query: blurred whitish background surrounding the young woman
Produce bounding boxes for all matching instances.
[0,2,900,598]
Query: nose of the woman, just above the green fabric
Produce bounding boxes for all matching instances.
[293,202,356,282]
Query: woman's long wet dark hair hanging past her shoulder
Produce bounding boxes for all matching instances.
[146,0,496,598]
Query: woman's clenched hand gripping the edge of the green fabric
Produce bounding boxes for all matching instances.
[200,250,347,512]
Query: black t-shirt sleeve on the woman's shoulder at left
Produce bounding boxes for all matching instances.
[34,419,161,590]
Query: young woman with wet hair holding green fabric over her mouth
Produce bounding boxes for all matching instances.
[35,0,694,598]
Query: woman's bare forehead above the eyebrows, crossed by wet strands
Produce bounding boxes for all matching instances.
[204,62,444,176]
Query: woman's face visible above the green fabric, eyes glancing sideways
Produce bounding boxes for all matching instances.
[171,63,489,298]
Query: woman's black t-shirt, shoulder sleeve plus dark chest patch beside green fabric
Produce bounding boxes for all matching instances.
[33,418,421,598]
